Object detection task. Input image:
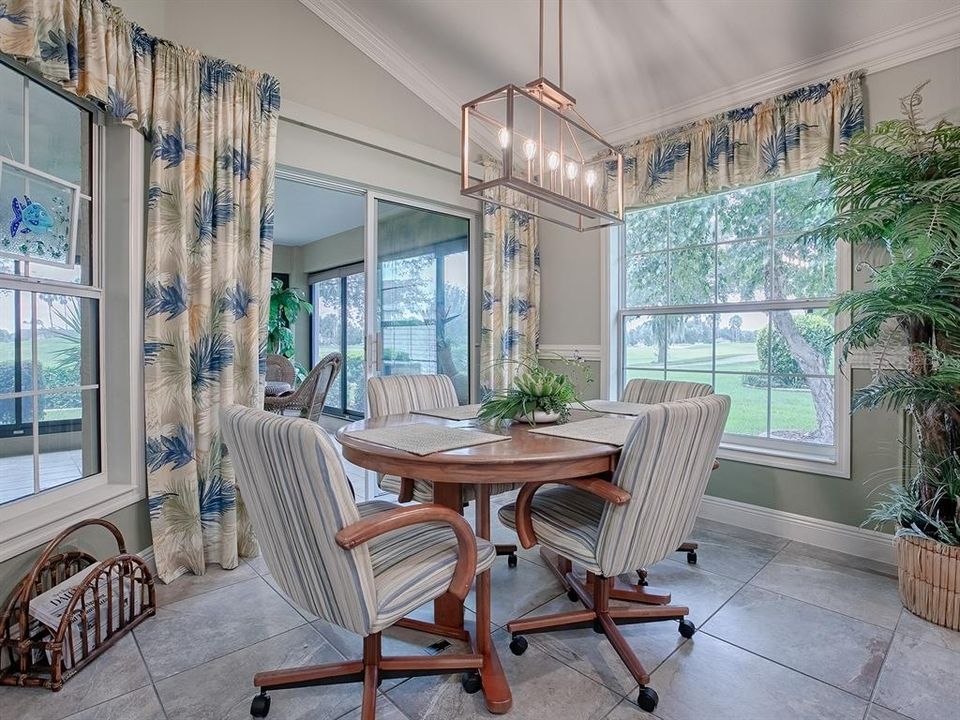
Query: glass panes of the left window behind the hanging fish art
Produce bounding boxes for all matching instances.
[0,65,101,504]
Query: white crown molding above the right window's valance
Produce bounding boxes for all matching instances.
[600,8,960,144]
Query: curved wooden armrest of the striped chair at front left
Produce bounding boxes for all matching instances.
[336,503,477,600]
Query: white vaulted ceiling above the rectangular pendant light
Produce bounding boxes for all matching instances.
[300,0,960,140]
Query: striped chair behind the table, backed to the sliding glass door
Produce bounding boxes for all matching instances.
[367,375,517,567]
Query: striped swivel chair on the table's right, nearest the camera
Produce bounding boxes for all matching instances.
[500,395,730,712]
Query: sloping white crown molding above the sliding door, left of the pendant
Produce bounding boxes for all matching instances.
[300,0,461,127]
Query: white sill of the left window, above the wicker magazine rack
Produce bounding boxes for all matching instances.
[0,475,144,562]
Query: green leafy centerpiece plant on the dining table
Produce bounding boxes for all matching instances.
[477,359,592,425]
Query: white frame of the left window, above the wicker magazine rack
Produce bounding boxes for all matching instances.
[0,66,146,561]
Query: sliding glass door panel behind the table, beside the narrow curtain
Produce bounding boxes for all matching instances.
[372,198,473,403]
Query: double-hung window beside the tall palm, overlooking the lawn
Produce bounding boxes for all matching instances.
[619,174,848,475]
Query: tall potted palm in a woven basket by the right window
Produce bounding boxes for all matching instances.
[802,85,960,630]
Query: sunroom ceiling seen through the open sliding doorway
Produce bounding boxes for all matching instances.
[273,178,364,245]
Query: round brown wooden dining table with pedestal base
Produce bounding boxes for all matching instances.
[337,411,620,713]
